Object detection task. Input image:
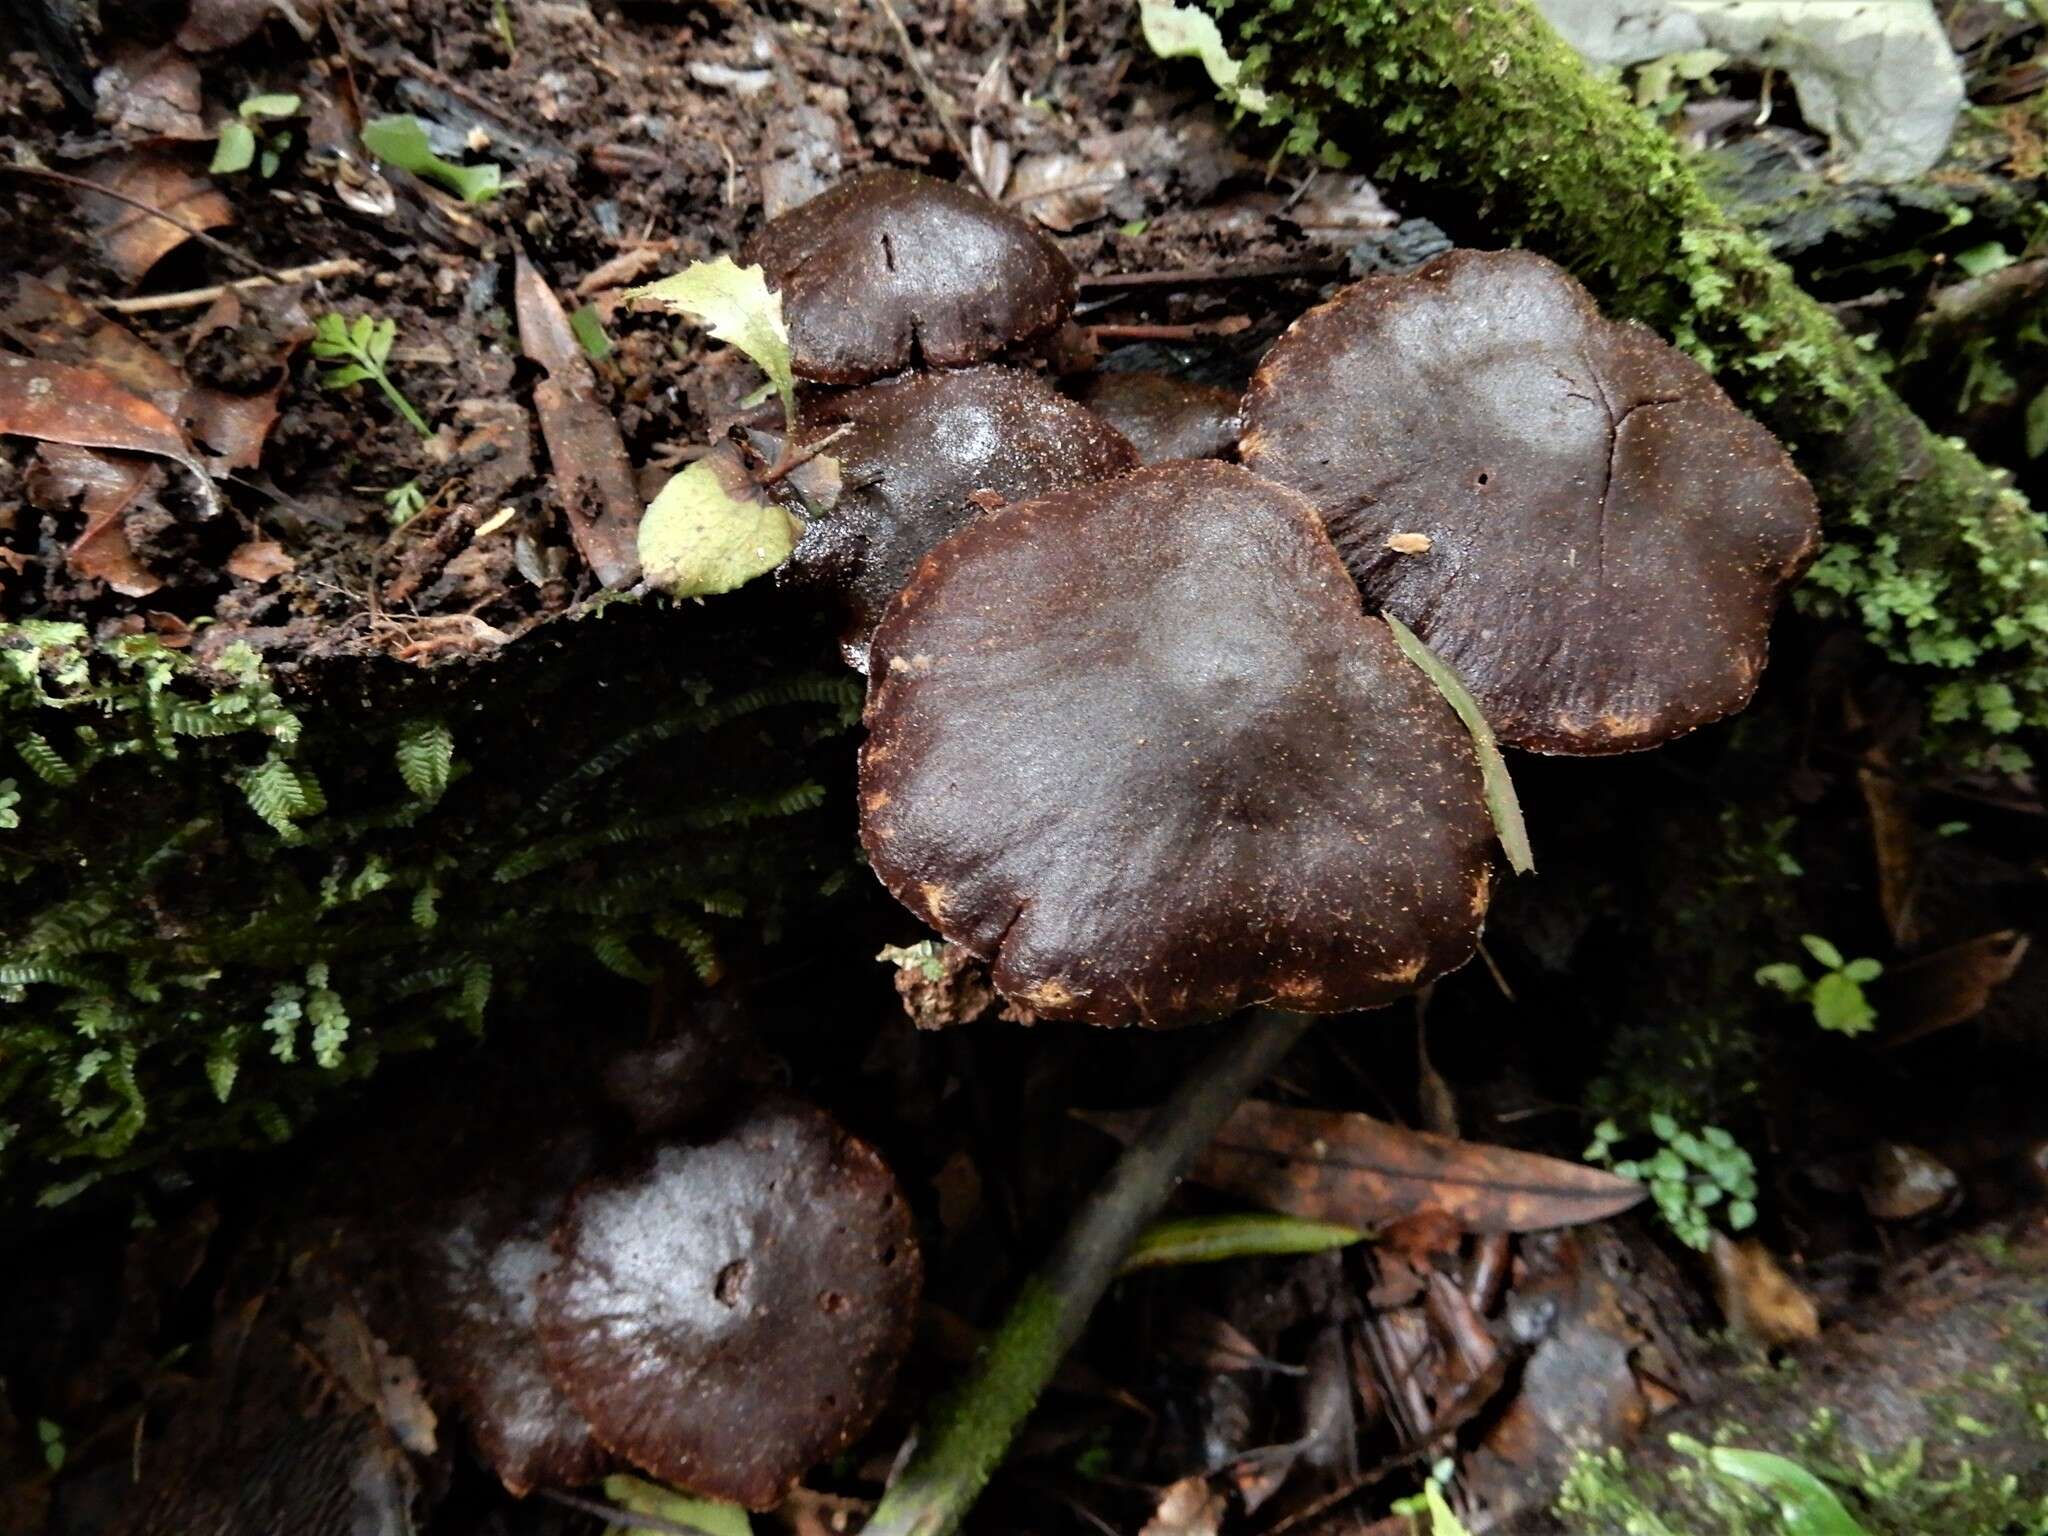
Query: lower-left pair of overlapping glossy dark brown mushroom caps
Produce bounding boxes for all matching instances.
[382,1089,922,1509]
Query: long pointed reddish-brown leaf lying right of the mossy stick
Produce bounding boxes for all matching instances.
[1081,1100,1645,1233]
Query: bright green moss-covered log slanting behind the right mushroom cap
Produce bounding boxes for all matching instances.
[1225,0,2048,762]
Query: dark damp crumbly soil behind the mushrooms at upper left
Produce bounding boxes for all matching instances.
[0,0,1400,679]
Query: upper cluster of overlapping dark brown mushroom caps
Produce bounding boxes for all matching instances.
[667,170,1819,1026]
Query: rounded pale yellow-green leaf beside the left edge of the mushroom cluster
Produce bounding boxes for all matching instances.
[639,455,803,598]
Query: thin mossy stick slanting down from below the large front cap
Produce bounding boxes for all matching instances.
[864,1008,1315,1536]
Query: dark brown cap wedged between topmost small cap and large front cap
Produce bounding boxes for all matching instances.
[782,367,1139,672]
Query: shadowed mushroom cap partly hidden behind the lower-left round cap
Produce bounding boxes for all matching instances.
[399,1135,612,1493]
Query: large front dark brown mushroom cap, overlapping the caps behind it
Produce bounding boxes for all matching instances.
[860,461,1493,1026]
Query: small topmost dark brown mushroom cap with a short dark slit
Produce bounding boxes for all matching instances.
[745,170,1075,383]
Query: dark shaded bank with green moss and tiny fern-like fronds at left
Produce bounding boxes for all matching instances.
[0,608,860,1204]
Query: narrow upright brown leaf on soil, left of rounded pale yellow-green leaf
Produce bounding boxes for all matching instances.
[512,256,647,586]
